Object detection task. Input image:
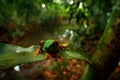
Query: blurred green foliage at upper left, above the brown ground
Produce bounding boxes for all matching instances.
[0,0,65,37]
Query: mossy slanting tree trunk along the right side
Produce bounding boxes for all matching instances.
[82,0,120,80]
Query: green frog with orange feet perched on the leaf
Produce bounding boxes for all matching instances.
[35,39,65,60]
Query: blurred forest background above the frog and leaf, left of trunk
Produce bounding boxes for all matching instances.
[0,0,115,46]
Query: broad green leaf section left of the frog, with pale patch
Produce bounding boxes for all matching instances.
[0,43,45,69]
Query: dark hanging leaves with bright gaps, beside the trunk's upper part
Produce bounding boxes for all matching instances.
[66,0,115,31]
